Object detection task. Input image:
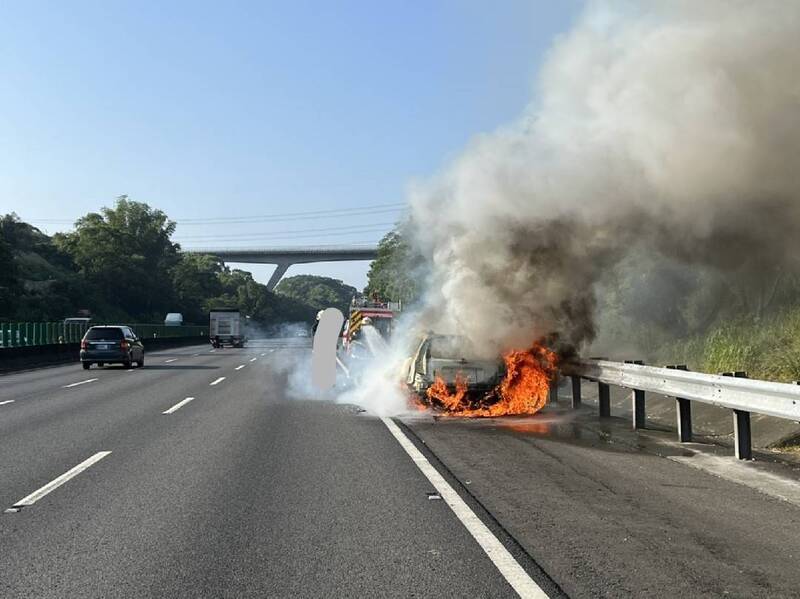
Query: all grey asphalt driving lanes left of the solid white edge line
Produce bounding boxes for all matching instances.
[0,340,536,597]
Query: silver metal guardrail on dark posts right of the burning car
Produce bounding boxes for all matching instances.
[562,360,800,459]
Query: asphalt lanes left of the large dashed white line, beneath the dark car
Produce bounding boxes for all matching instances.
[0,346,241,505]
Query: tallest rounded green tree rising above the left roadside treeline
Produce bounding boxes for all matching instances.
[55,196,179,320]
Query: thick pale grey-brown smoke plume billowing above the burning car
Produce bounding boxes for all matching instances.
[411,0,800,355]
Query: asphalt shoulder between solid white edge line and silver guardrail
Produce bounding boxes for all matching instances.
[408,407,800,598]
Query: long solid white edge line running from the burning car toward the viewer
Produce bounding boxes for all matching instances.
[381,418,547,599]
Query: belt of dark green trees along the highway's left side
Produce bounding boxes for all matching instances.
[0,196,355,326]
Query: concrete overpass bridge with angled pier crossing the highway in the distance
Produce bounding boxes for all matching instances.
[185,245,378,291]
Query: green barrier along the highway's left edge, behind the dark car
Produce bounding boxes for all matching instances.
[0,322,208,349]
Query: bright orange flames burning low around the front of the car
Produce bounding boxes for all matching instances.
[418,343,558,418]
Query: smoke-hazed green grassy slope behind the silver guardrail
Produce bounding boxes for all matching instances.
[593,255,800,381]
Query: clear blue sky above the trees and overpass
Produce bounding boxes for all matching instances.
[0,0,581,287]
